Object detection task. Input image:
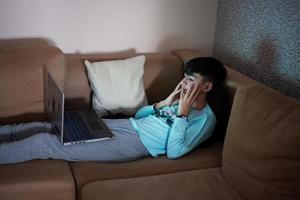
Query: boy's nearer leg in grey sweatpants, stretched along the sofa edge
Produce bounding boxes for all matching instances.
[0,120,149,164]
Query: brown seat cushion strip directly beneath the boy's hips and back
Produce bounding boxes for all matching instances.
[71,143,223,191]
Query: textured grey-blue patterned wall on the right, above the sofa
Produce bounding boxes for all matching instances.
[214,0,300,99]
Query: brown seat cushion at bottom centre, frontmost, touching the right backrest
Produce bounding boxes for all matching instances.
[81,168,243,200]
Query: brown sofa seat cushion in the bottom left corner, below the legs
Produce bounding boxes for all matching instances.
[0,160,76,200]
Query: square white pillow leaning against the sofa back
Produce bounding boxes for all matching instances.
[84,55,148,116]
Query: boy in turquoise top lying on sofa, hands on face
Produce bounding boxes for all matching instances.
[0,57,226,164]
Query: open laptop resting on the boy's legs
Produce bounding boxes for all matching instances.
[45,71,113,145]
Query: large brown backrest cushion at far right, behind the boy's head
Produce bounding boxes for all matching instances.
[222,86,300,200]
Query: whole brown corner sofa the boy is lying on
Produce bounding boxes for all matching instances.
[0,41,300,200]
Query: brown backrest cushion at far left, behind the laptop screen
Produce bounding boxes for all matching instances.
[0,45,65,124]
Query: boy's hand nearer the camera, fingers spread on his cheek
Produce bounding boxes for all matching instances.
[177,81,200,116]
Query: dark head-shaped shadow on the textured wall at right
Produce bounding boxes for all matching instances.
[215,38,300,99]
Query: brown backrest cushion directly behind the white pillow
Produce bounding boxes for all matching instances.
[65,53,183,109]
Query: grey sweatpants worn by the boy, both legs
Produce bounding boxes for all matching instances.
[0,119,150,164]
